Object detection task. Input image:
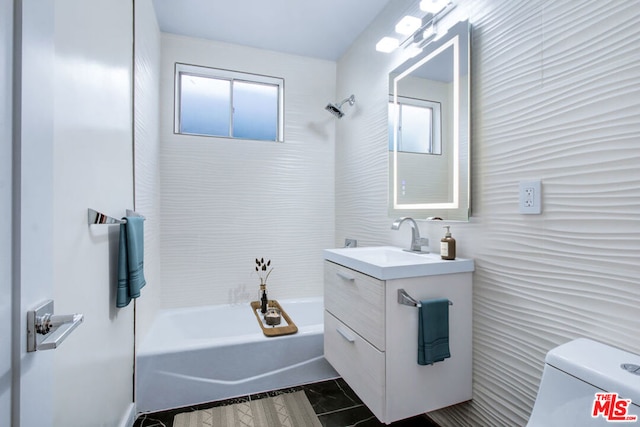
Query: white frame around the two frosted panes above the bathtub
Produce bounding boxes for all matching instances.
[173,62,284,142]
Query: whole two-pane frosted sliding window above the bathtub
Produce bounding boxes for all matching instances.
[174,63,284,142]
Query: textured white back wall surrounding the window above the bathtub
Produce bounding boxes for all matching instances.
[160,34,336,307]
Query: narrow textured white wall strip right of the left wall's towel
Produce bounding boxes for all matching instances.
[134,0,162,348]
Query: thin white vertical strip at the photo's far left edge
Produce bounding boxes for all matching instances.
[0,0,13,426]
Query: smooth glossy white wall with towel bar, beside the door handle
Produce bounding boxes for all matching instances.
[52,0,135,427]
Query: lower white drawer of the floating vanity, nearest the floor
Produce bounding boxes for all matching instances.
[324,310,385,420]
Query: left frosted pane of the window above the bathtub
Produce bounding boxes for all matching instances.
[180,74,231,136]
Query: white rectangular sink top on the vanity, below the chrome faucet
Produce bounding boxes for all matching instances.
[324,246,474,280]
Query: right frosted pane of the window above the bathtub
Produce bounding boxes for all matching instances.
[233,81,278,141]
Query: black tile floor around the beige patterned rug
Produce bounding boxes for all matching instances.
[133,378,438,427]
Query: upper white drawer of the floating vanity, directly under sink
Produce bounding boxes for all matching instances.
[324,261,385,351]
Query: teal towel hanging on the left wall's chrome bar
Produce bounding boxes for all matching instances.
[116,216,147,308]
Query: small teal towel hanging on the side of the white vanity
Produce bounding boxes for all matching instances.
[418,298,451,365]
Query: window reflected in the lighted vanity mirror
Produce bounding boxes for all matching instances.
[389,96,442,154]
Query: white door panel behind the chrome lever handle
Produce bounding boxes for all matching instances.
[11,0,54,427]
